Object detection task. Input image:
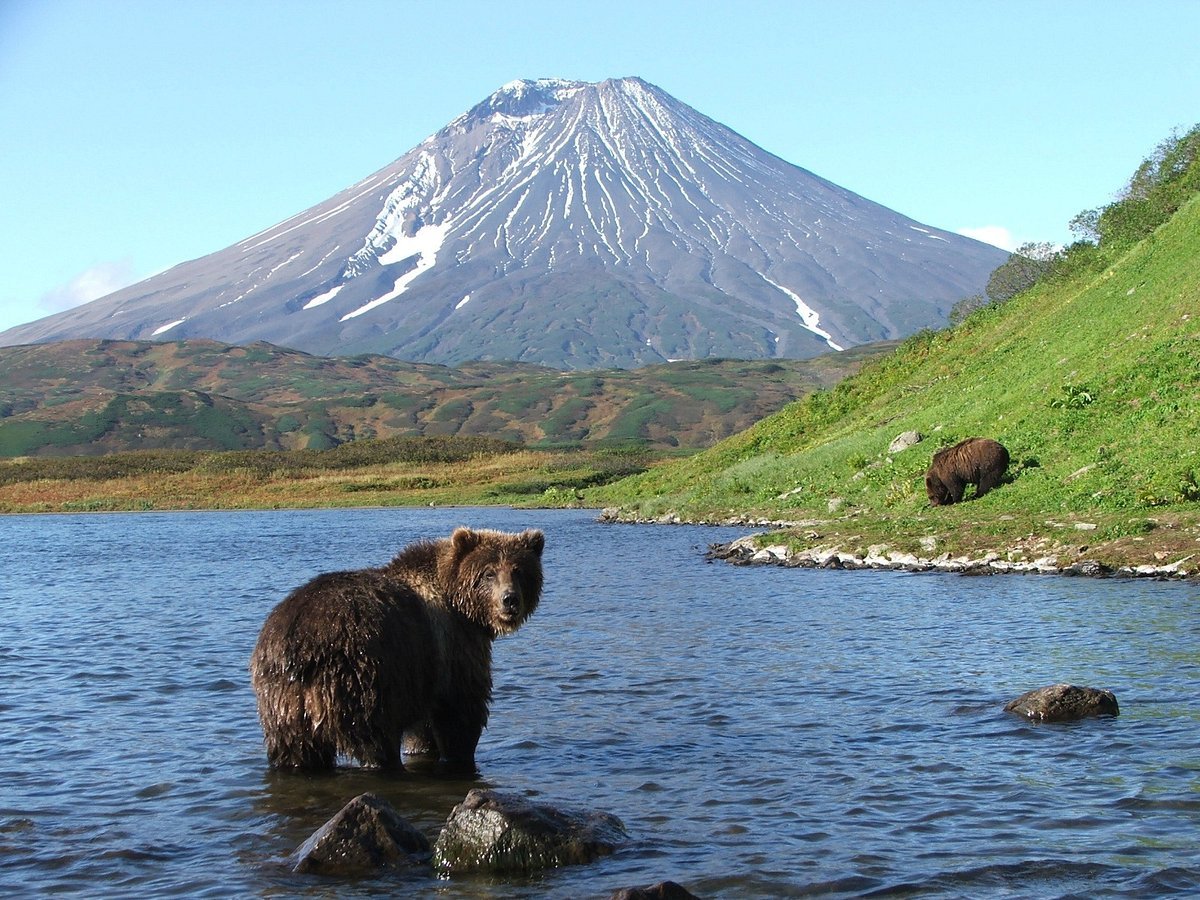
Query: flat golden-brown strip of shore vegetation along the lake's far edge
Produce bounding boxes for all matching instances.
[0,437,661,512]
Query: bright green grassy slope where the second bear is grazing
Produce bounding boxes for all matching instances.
[589,198,1200,571]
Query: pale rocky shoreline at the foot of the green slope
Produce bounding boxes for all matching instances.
[598,509,1200,580]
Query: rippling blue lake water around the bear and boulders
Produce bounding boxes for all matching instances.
[0,509,1200,898]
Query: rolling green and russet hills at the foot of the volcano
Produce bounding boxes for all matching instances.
[0,340,895,457]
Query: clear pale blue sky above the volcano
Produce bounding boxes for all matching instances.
[0,0,1200,330]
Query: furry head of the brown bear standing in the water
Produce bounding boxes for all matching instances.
[446,528,546,635]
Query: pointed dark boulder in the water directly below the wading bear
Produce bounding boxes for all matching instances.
[294,793,430,875]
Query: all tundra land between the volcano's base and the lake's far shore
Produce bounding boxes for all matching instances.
[0,341,894,512]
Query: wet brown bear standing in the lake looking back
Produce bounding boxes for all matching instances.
[250,528,545,770]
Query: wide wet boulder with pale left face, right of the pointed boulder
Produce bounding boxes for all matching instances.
[433,788,629,872]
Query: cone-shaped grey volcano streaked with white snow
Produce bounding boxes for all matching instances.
[0,78,1007,368]
